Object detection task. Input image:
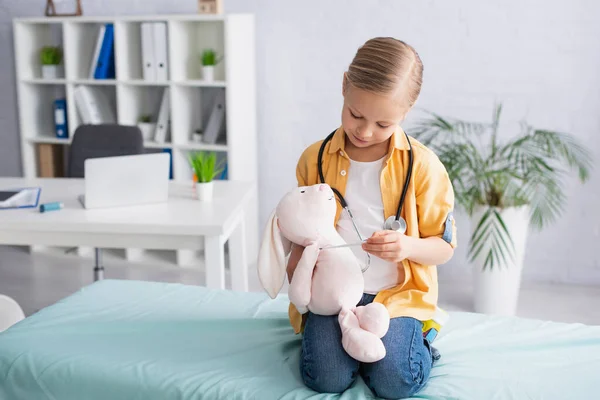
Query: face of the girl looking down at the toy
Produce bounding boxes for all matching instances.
[342,79,406,148]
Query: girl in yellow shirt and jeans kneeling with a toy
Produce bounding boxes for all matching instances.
[287,38,456,398]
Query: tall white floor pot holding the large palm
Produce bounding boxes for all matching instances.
[471,206,529,316]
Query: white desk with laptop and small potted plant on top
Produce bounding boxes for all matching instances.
[0,178,253,291]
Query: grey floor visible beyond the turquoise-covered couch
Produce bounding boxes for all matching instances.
[0,246,600,325]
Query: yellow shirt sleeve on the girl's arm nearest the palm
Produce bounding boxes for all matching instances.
[415,153,457,248]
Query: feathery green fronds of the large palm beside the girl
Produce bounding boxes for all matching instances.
[411,104,592,268]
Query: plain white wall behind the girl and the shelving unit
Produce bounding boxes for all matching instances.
[0,0,600,284]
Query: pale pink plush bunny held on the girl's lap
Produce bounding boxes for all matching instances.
[258,184,390,362]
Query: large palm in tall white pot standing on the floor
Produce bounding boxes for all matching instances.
[413,105,592,315]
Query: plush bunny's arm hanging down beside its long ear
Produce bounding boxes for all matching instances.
[288,243,319,314]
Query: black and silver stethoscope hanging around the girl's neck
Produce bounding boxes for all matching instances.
[317,131,413,272]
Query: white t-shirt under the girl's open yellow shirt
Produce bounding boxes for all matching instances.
[336,157,398,294]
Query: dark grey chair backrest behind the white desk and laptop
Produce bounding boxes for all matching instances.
[67,124,144,178]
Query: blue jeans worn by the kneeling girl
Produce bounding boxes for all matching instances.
[300,294,437,399]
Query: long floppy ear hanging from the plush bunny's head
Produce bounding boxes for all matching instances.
[258,211,291,299]
